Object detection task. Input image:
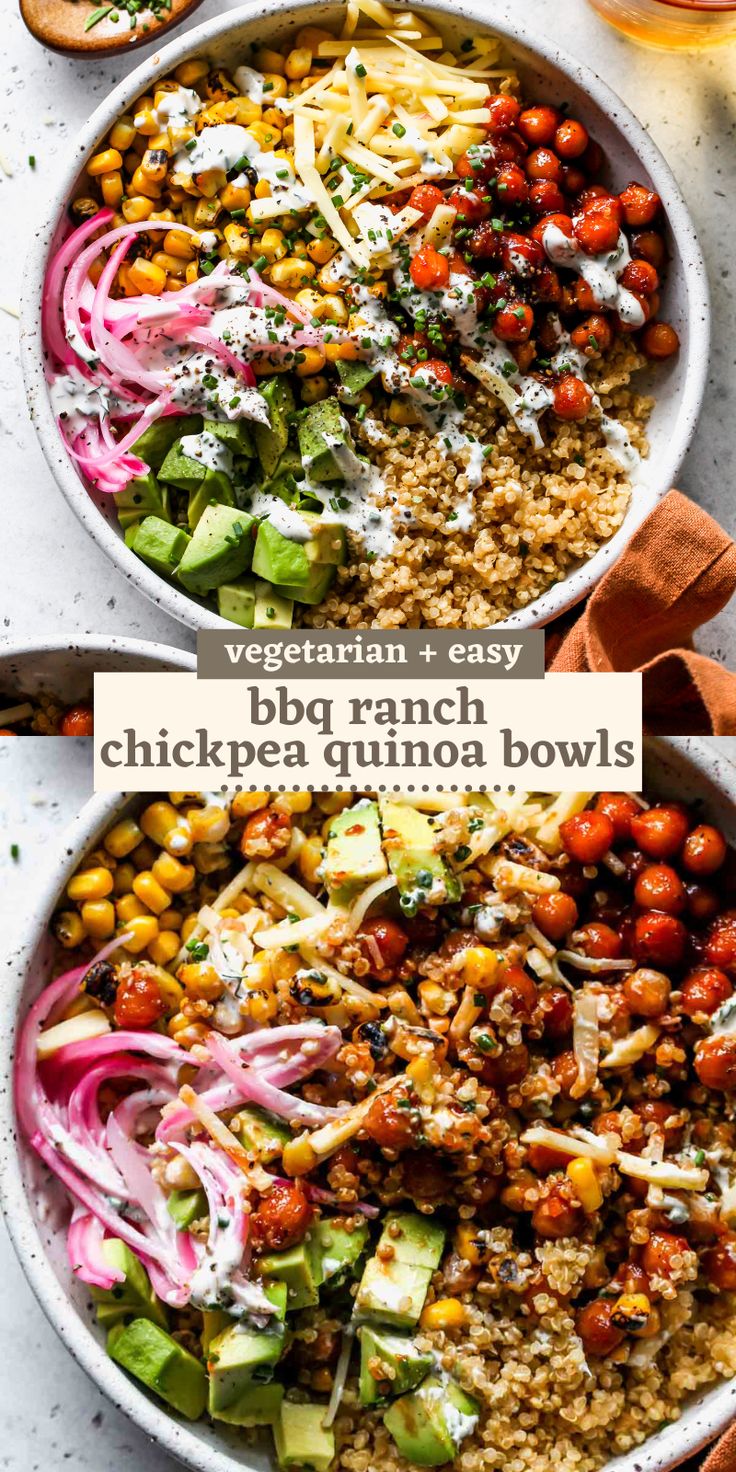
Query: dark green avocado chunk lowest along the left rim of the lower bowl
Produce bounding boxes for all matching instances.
[107,1319,208,1420]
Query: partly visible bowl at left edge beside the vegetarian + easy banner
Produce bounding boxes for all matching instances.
[0,634,197,721]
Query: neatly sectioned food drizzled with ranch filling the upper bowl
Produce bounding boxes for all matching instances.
[35,0,699,627]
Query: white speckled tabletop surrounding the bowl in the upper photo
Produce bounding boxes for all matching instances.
[0,0,736,667]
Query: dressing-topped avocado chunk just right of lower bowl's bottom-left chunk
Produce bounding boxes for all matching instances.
[208,1282,287,1415]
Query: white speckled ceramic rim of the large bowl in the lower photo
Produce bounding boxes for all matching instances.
[0,737,736,1472]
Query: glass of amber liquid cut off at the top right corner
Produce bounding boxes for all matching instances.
[590,0,736,52]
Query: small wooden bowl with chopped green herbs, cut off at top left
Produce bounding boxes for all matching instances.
[19,0,202,56]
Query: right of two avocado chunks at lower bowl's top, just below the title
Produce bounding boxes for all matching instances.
[380,798,462,916]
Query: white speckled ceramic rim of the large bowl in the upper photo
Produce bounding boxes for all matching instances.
[21,0,710,629]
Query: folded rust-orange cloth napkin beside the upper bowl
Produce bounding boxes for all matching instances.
[548,490,736,736]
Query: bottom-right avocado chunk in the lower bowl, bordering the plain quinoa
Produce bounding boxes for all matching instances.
[383,1376,478,1468]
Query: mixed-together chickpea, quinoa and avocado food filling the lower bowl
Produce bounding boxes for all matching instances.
[15,793,736,1472]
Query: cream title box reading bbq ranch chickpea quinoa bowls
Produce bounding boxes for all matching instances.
[94,673,642,792]
